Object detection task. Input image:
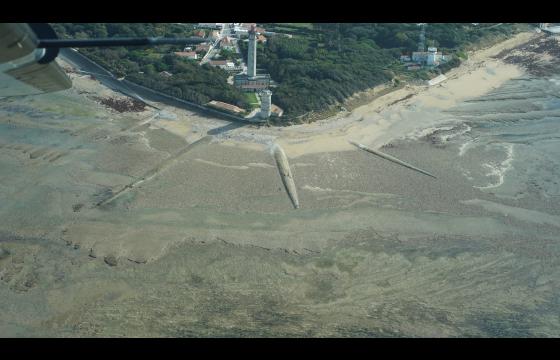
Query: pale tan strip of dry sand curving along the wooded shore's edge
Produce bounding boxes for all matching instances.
[59,32,540,158]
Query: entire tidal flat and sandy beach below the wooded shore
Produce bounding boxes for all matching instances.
[0,29,560,337]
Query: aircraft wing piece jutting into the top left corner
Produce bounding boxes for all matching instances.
[0,23,72,97]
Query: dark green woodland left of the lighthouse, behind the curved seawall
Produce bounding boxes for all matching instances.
[53,23,250,109]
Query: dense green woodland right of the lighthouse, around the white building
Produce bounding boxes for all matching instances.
[252,23,516,116]
